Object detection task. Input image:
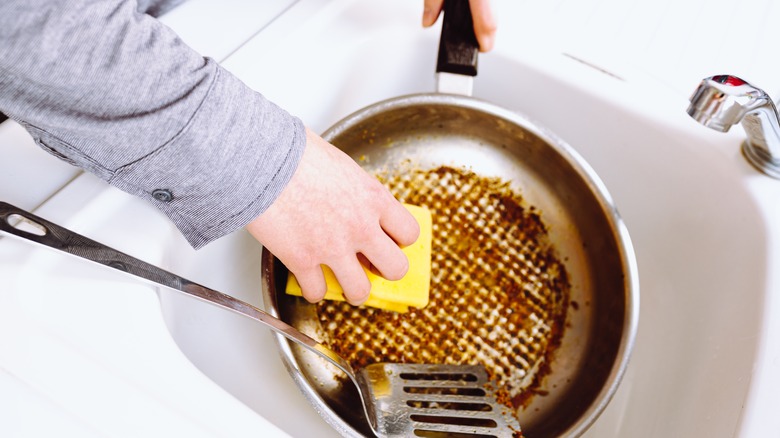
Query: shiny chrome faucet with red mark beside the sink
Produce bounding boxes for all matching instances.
[688,75,780,179]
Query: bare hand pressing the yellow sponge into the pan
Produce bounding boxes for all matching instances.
[246,130,420,305]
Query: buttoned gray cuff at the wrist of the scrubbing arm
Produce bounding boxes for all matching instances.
[109,67,306,248]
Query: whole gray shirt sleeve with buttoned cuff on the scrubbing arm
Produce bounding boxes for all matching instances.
[0,0,306,248]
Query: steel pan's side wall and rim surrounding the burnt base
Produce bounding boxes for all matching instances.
[263,94,638,437]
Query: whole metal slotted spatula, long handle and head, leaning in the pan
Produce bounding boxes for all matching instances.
[0,202,520,437]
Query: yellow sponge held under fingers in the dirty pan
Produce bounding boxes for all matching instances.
[286,204,432,313]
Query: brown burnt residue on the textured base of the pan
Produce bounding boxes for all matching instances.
[317,167,569,409]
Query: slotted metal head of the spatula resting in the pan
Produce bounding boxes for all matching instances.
[356,363,522,438]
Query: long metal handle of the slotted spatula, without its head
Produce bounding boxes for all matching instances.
[0,202,353,375]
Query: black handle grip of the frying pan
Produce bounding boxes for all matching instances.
[436,0,479,76]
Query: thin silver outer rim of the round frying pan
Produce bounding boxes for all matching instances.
[261,92,640,437]
